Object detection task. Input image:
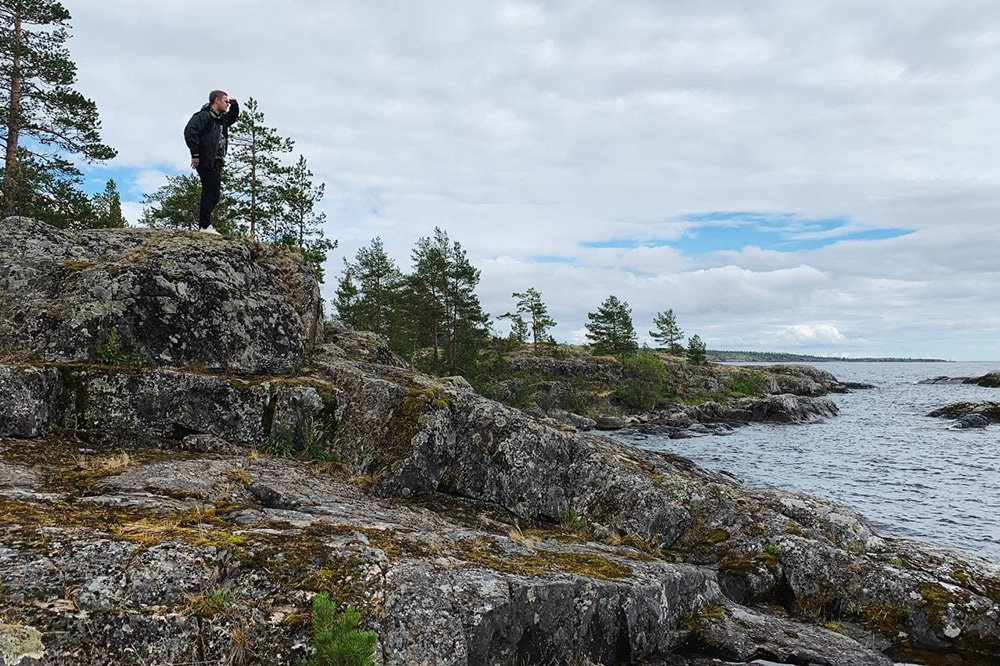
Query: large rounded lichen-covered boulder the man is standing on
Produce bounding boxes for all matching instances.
[0,218,322,373]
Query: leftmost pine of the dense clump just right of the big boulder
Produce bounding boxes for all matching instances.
[336,238,403,340]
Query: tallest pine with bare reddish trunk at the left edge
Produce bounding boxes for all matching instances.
[0,0,115,215]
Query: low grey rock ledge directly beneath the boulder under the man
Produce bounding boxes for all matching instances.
[0,365,337,452]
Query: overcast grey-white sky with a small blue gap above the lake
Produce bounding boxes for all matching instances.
[63,0,1000,360]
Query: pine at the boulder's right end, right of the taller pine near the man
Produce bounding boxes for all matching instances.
[275,155,337,282]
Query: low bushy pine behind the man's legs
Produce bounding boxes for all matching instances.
[139,174,240,235]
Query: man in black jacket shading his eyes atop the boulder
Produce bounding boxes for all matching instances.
[184,90,240,234]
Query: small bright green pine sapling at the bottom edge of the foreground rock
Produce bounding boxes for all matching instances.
[302,592,378,666]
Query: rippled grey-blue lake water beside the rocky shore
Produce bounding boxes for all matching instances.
[620,362,1000,562]
